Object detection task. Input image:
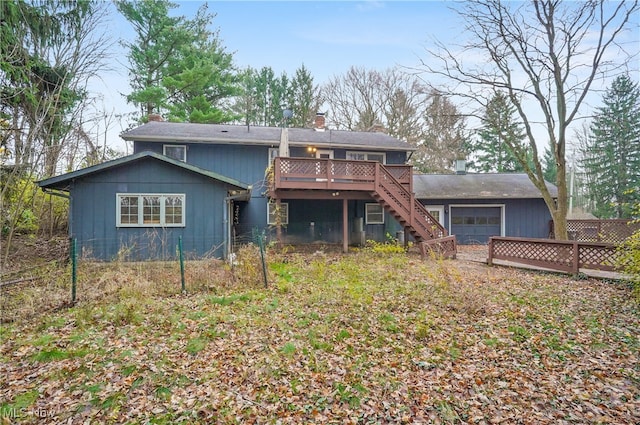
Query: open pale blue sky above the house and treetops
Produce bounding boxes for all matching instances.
[95,0,639,151]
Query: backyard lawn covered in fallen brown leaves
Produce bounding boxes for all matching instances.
[0,251,640,424]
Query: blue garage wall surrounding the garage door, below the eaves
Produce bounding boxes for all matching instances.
[420,199,551,243]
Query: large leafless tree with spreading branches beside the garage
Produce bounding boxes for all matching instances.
[422,0,638,238]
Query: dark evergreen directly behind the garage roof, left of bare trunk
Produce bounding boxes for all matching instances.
[471,92,527,173]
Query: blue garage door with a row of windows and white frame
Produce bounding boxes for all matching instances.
[451,207,502,244]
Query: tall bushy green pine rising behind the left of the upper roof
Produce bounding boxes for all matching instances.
[116,0,238,123]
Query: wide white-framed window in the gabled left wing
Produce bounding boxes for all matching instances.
[116,193,185,227]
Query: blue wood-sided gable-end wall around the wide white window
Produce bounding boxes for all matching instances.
[71,158,227,260]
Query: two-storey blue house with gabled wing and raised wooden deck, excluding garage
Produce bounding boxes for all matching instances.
[39,114,445,260]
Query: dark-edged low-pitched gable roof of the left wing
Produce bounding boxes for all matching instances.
[37,151,251,191]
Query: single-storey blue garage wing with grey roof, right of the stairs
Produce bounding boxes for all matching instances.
[413,172,557,244]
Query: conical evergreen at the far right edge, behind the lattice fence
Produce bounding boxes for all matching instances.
[581,75,640,218]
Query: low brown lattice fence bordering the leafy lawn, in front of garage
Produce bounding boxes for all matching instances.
[487,236,618,274]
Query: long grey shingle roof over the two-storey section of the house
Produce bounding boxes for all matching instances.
[120,121,415,151]
